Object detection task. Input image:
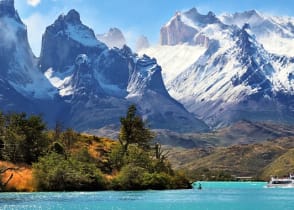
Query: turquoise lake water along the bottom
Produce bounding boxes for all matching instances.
[0,182,294,210]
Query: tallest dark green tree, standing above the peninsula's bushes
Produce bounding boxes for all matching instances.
[119,105,154,154]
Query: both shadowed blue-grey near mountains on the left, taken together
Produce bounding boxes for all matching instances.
[0,0,208,132]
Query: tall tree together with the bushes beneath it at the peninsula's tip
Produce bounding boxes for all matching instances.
[109,105,191,190]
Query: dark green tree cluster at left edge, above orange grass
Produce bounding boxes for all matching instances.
[0,113,49,164]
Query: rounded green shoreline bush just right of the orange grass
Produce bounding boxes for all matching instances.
[33,153,106,191]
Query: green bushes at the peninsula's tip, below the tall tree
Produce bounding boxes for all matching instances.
[111,145,191,190]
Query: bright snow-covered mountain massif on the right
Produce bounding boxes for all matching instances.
[139,8,294,129]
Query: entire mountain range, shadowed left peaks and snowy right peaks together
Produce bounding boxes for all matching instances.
[0,0,294,141]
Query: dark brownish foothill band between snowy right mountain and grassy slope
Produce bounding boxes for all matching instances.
[157,121,294,148]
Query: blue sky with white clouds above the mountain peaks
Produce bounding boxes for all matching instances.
[15,0,294,56]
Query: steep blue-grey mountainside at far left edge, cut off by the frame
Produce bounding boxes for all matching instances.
[0,0,62,122]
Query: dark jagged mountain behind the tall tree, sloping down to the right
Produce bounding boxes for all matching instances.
[40,10,207,131]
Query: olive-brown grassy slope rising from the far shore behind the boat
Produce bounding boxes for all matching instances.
[169,137,294,179]
